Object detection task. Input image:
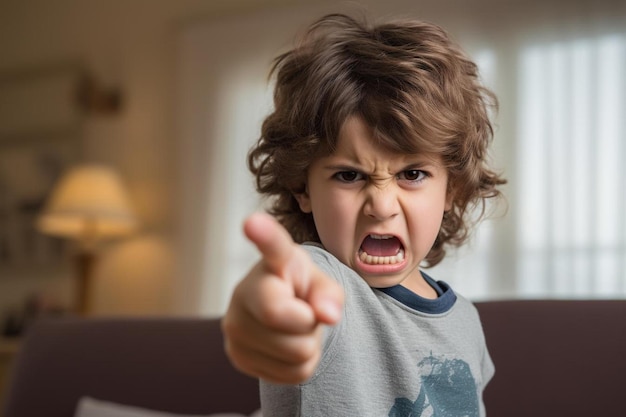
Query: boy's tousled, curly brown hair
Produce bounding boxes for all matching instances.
[248,14,506,266]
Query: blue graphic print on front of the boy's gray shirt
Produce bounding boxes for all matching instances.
[389,353,480,417]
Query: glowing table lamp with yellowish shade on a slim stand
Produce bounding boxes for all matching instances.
[37,164,137,315]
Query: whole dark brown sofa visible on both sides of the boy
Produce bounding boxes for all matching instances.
[4,300,626,417]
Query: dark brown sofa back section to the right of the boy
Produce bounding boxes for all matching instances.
[476,300,626,417]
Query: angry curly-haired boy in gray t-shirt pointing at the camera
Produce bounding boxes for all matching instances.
[223,15,504,417]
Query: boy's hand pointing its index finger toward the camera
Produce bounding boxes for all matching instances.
[222,213,343,384]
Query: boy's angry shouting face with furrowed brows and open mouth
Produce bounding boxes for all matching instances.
[296,118,450,288]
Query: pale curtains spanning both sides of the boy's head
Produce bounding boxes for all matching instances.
[179,2,626,315]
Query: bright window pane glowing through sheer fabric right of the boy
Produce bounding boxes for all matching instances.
[516,35,626,297]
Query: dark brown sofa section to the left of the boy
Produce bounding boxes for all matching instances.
[3,318,259,417]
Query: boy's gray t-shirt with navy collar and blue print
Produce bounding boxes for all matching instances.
[261,245,494,417]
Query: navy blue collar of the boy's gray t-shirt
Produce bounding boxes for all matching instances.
[376,272,456,314]
